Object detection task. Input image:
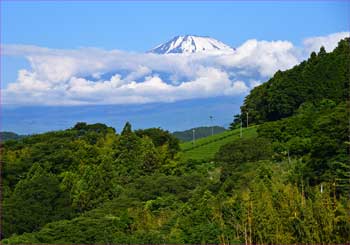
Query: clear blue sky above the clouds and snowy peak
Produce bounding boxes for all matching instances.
[1,1,350,51]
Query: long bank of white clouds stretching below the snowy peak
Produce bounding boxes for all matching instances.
[2,33,348,105]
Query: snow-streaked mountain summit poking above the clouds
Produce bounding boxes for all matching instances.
[149,35,234,54]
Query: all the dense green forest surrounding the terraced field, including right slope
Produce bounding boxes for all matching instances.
[1,39,350,244]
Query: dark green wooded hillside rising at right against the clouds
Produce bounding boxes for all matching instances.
[241,39,350,123]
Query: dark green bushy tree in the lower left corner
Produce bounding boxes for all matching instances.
[2,163,71,236]
